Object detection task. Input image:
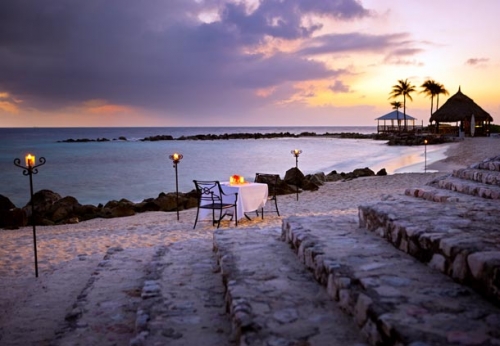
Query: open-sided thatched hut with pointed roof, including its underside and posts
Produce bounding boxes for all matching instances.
[430,87,493,137]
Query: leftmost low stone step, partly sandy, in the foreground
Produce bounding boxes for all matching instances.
[53,247,155,346]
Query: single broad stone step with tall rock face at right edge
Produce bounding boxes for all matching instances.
[359,196,500,305]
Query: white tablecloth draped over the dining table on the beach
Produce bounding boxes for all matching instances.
[200,182,268,220]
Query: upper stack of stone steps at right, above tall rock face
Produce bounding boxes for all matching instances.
[359,157,500,306]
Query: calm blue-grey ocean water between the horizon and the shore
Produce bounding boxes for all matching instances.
[0,126,447,206]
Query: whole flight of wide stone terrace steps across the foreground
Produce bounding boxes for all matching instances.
[0,156,500,346]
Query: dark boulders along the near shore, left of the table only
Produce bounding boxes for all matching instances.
[0,190,197,229]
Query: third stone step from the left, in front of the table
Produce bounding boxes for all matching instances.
[214,228,364,346]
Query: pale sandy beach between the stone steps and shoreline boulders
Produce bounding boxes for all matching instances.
[0,137,500,344]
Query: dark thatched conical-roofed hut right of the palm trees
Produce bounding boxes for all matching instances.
[430,87,493,135]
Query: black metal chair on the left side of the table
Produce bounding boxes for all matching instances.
[193,180,238,229]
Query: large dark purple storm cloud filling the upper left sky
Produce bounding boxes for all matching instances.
[0,0,372,116]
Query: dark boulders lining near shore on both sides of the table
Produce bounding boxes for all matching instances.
[0,167,387,229]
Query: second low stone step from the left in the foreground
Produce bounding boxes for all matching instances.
[130,238,234,346]
